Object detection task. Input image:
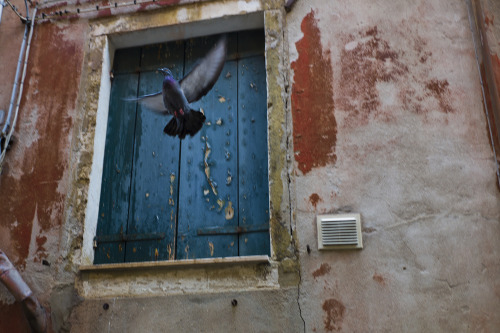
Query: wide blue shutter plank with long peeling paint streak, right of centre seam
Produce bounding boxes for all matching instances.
[177,33,238,259]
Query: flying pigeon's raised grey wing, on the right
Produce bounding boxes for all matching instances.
[179,35,227,103]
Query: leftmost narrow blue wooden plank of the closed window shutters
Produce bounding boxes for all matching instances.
[94,74,138,264]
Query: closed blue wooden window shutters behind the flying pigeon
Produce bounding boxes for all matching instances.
[94,30,270,264]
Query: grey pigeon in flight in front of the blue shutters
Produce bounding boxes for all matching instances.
[130,35,227,139]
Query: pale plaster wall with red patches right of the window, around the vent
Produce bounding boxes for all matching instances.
[287,0,500,332]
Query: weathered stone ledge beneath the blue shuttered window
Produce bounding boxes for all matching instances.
[76,256,280,299]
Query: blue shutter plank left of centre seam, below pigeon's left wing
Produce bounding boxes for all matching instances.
[125,72,179,261]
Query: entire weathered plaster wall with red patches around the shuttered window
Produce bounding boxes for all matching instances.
[0,0,500,332]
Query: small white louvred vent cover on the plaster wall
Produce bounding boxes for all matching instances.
[317,214,363,250]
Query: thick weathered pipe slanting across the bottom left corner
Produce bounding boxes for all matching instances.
[0,250,48,333]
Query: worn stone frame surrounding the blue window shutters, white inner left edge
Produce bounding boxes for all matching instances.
[77,0,297,285]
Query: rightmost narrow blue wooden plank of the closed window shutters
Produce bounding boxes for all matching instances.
[238,55,270,255]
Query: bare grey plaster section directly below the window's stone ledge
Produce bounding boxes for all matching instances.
[72,289,303,332]
